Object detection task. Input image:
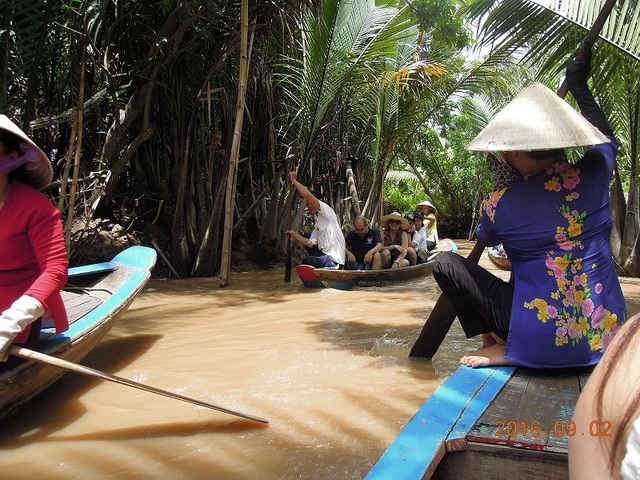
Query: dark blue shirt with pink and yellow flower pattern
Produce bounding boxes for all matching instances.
[477,137,626,368]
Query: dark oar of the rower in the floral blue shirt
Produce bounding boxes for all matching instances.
[409,0,616,358]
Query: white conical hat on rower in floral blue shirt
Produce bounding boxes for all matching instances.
[467,82,609,152]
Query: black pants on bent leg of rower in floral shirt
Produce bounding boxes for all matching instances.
[433,252,513,341]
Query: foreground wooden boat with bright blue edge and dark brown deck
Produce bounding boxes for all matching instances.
[365,366,592,480]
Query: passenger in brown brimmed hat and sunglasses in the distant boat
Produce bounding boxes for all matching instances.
[380,212,416,268]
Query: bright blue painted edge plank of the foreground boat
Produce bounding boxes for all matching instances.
[365,366,510,480]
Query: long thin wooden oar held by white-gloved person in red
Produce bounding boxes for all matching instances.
[9,345,269,423]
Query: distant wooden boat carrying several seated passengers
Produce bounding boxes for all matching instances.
[298,238,458,290]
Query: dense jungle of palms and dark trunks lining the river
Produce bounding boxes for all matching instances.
[0,0,640,286]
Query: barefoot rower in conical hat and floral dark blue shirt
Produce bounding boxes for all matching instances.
[433,39,626,368]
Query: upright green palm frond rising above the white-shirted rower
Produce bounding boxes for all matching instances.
[283,0,413,164]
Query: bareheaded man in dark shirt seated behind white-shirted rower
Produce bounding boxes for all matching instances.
[345,215,382,270]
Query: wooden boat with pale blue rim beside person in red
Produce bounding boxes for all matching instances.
[0,246,156,418]
